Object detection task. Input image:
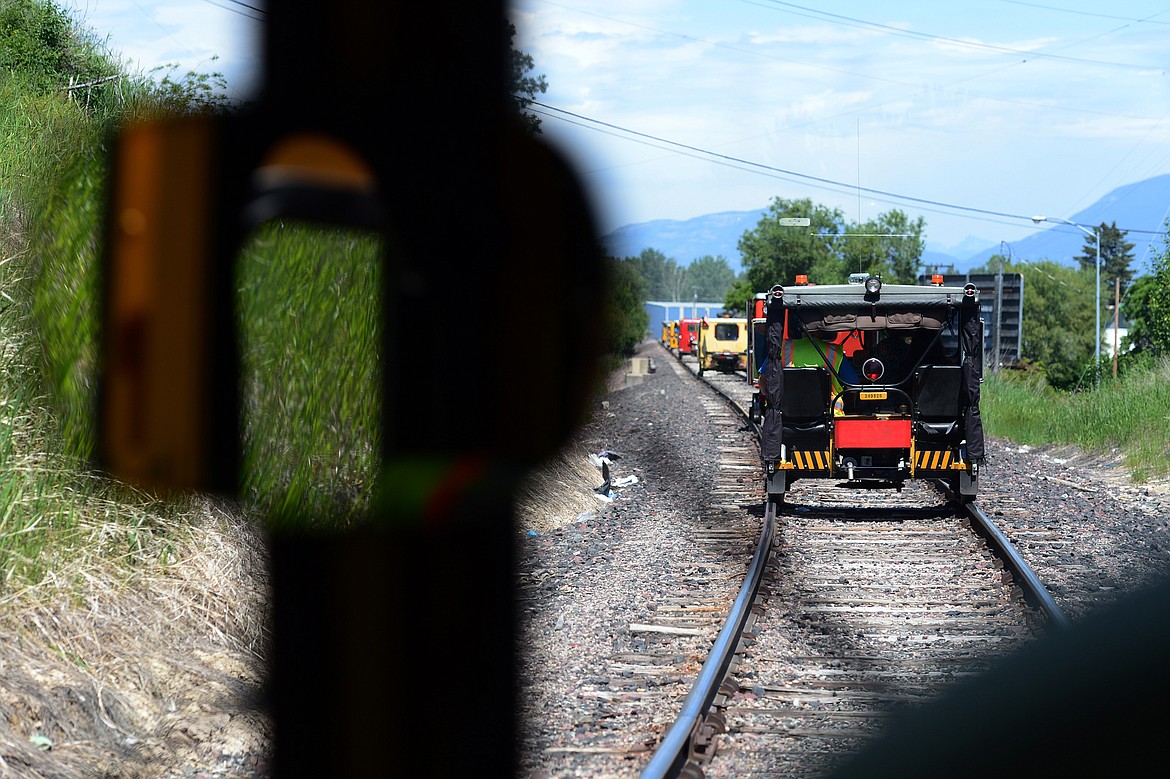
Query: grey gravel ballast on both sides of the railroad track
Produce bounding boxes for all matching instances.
[517,343,1170,779]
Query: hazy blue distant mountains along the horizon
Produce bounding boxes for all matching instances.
[601,174,1170,274]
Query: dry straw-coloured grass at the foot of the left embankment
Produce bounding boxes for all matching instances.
[0,498,270,779]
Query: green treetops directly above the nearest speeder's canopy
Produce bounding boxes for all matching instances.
[739,198,925,291]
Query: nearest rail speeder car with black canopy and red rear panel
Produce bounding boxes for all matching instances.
[761,274,984,502]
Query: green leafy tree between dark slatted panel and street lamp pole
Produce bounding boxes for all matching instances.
[1004,260,1095,390]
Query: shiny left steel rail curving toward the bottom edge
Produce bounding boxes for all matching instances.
[640,502,776,779]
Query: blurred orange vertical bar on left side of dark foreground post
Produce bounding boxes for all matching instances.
[101,122,219,488]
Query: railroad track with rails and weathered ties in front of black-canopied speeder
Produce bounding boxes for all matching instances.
[642,350,1066,779]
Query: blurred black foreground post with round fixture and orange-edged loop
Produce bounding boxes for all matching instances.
[98,0,605,779]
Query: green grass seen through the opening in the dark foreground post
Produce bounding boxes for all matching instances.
[236,222,383,526]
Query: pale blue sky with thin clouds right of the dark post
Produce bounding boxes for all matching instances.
[511,0,1170,247]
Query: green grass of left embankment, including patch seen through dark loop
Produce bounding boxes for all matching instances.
[0,80,380,595]
